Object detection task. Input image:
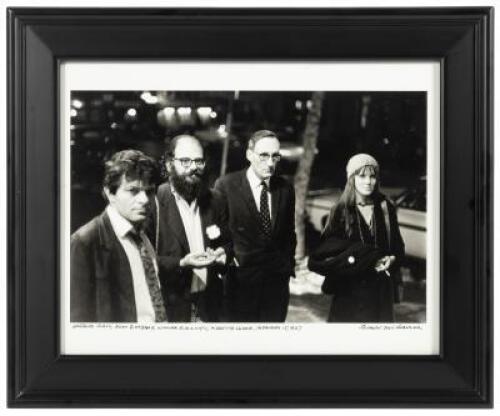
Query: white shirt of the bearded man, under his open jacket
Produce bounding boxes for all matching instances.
[171,186,207,293]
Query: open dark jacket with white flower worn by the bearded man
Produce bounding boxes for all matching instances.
[150,183,231,304]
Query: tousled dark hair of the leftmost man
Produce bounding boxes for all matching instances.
[103,149,157,194]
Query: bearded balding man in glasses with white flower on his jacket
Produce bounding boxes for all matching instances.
[153,135,229,322]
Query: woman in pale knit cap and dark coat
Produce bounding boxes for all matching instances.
[313,153,404,322]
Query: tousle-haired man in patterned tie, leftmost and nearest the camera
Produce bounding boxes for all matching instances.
[70,150,166,323]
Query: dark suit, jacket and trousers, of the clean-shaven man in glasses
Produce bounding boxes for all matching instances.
[215,170,296,322]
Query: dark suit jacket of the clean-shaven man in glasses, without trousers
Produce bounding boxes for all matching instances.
[215,170,297,277]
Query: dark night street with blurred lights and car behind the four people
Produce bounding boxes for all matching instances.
[71,91,427,322]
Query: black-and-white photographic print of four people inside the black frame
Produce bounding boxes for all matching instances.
[63,64,437,354]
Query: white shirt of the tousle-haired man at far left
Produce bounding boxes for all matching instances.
[106,205,160,322]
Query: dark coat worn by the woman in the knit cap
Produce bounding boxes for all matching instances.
[309,197,404,322]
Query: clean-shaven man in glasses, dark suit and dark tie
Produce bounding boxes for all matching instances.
[215,130,296,322]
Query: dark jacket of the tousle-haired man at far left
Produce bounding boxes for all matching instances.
[70,211,137,322]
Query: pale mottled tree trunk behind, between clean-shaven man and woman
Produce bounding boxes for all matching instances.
[294,91,325,260]
